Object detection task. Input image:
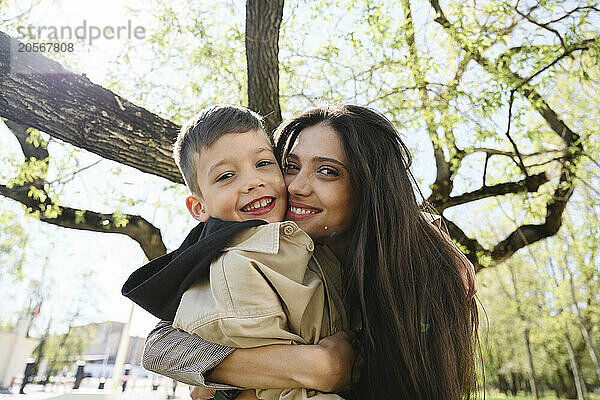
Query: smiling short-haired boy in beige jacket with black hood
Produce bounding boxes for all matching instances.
[122,105,347,400]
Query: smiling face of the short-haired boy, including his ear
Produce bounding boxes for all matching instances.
[186,131,287,222]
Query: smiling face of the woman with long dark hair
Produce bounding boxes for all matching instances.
[284,124,358,243]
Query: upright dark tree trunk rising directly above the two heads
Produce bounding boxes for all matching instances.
[246,0,283,134]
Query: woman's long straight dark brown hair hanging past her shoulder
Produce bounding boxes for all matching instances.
[275,105,478,400]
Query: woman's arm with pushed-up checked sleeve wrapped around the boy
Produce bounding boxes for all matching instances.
[143,321,354,392]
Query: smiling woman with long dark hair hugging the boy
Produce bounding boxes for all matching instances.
[144,106,477,399]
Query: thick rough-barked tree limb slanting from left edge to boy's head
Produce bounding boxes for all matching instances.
[0,32,183,183]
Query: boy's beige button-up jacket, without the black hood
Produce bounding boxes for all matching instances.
[173,221,348,400]
